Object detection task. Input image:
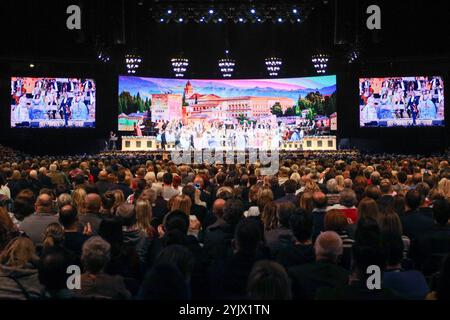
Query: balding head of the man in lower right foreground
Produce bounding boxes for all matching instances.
[314,231,343,264]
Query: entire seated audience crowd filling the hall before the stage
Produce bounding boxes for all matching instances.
[0,147,450,300]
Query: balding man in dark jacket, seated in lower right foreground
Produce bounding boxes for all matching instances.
[288,231,349,300]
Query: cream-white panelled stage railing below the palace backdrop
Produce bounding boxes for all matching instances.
[122,136,337,151]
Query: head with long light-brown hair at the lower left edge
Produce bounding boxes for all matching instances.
[0,237,39,268]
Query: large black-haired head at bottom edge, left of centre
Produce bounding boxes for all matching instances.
[138,264,191,301]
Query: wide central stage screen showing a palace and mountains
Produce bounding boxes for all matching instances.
[118,76,337,148]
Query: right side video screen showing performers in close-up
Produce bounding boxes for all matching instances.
[359,76,445,127]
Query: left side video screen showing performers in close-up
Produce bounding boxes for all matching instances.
[11,77,96,128]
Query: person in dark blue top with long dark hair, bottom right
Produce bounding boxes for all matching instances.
[382,234,429,300]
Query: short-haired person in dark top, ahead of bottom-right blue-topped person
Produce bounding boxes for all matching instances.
[402,190,434,242]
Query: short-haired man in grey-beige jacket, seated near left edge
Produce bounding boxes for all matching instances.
[19,194,58,245]
